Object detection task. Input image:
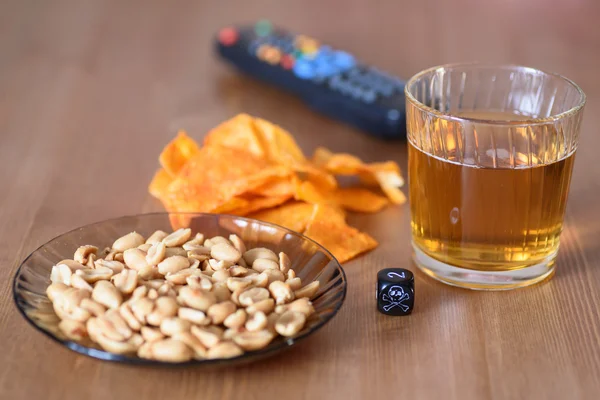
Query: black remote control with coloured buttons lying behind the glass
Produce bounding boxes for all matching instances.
[216,21,406,139]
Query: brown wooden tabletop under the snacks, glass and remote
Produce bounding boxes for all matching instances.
[0,0,600,400]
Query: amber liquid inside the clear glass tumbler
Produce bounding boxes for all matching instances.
[409,113,575,271]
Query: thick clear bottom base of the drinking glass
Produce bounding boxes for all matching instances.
[413,243,556,290]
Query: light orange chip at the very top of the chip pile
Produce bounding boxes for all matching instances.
[204,114,267,157]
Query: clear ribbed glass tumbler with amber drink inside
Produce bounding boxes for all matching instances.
[405,64,585,290]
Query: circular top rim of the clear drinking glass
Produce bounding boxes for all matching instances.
[404,62,586,126]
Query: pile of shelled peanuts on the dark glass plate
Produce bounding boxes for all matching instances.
[46,228,319,362]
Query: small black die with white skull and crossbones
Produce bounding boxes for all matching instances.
[377,268,415,315]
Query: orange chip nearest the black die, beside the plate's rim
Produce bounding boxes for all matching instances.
[304,204,378,263]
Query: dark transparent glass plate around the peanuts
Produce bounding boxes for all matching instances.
[13,213,346,366]
